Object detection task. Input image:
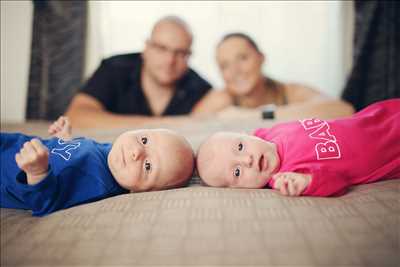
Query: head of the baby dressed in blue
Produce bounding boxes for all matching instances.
[107,129,194,192]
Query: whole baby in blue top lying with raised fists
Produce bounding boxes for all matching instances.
[0,117,194,216]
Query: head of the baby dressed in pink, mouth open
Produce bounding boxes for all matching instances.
[196,132,279,188]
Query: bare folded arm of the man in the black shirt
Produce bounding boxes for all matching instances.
[65,93,187,128]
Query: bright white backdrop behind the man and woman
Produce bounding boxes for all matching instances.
[85,1,352,96]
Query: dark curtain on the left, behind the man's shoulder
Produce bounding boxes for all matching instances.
[26,1,87,120]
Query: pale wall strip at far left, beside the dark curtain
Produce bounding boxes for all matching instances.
[0,1,33,123]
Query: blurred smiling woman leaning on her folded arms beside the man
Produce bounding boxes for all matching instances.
[195,32,353,119]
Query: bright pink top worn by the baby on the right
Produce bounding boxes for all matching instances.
[254,98,400,196]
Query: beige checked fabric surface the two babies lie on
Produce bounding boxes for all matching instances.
[0,122,400,267]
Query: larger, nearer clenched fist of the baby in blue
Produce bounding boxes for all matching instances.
[15,138,49,185]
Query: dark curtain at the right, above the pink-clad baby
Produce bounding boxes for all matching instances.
[342,1,400,110]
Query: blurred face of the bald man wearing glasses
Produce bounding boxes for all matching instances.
[143,21,192,86]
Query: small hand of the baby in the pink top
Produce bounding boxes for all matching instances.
[272,172,311,196]
